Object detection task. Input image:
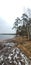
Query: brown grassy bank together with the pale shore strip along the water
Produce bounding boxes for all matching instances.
[0,36,31,58]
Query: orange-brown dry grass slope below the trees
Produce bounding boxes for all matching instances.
[10,36,31,58]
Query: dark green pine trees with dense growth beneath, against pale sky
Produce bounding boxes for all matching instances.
[13,10,31,38]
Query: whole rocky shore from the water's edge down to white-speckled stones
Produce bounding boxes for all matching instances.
[0,37,31,65]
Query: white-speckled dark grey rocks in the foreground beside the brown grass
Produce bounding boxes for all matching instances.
[0,43,31,65]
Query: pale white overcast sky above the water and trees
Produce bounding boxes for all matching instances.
[0,0,31,33]
